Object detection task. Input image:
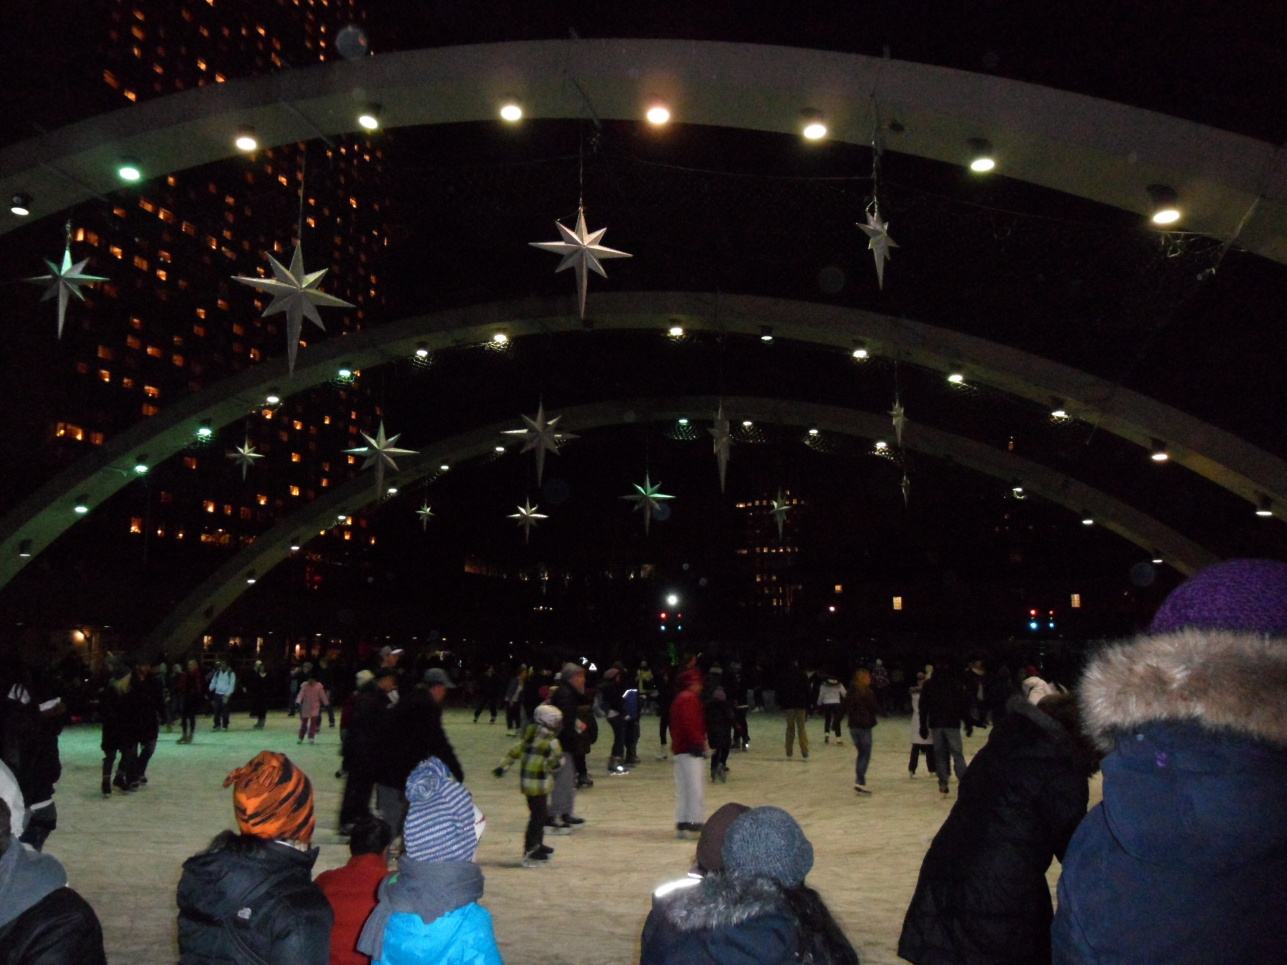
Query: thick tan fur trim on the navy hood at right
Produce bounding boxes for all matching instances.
[1080,629,1287,751]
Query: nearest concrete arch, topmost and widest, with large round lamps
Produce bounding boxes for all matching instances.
[0,40,1287,262]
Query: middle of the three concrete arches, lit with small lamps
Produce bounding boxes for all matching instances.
[0,292,1287,587]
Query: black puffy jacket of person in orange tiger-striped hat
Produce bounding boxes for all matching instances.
[178,831,335,965]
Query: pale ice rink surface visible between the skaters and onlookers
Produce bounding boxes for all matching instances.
[45,709,1099,965]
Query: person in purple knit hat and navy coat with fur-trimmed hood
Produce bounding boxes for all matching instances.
[1051,560,1287,965]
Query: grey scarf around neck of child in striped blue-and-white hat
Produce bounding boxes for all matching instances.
[358,857,483,960]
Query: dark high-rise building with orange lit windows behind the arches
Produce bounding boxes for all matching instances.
[2,0,387,635]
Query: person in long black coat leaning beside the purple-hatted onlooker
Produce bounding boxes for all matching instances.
[898,695,1098,965]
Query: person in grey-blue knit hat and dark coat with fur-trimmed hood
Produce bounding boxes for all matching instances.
[640,807,858,965]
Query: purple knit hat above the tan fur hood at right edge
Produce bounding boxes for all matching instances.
[1148,560,1287,637]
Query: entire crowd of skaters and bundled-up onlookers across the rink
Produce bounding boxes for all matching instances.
[0,560,1287,965]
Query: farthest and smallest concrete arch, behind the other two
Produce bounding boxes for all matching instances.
[145,396,1216,652]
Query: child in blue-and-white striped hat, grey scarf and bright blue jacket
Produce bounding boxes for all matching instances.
[358,758,501,965]
